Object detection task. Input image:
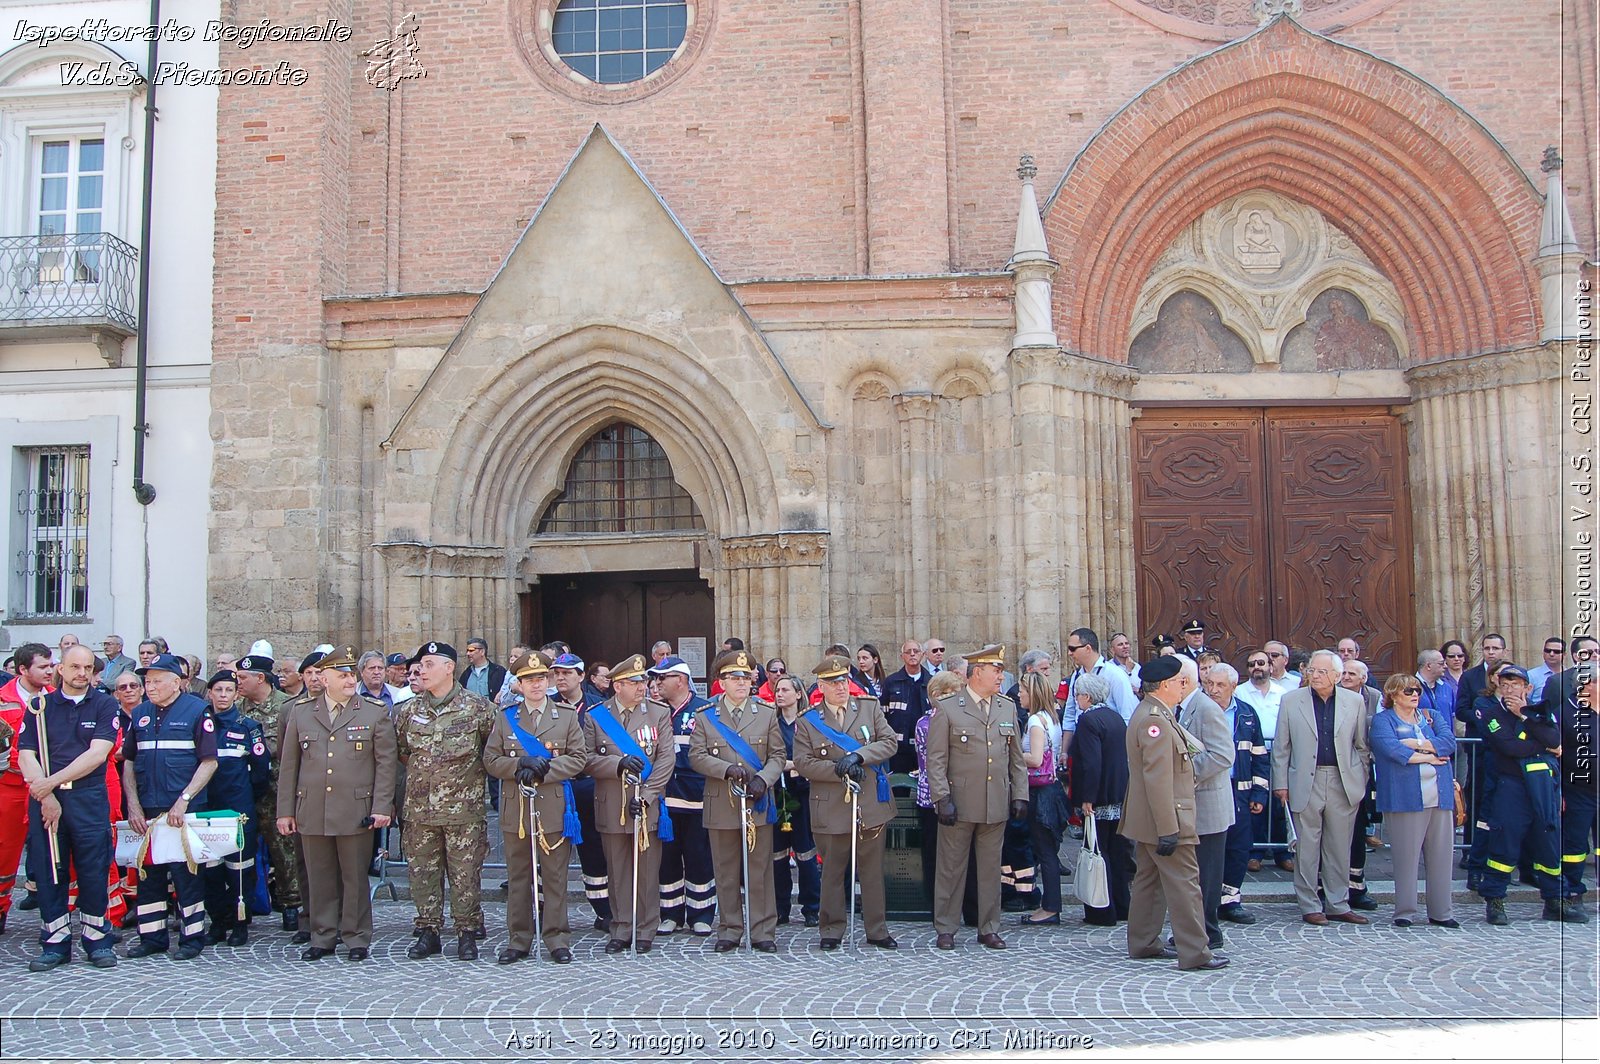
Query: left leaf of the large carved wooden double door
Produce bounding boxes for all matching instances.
[1133,413,1269,653]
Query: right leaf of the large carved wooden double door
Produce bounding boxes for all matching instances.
[1267,411,1414,675]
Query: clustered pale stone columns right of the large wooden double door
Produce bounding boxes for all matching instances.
[1405,344,1573,661]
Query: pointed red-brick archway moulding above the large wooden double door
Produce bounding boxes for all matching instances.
[1045,18,1542,362]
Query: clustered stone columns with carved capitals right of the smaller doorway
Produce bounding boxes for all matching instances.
[715,531,827,669]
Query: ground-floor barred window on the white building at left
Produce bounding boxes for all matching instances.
[16,446,90,618]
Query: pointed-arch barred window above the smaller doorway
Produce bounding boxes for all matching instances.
[539,422,706,533]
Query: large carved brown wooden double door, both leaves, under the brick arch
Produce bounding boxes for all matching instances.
[1133,406,1414,675]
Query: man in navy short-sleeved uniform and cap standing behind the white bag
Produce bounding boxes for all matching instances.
[122,654,216,960]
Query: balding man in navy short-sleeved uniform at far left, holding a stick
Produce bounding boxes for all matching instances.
[18,646,117,971]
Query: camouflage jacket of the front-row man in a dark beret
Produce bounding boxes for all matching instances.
[395,685,494,827]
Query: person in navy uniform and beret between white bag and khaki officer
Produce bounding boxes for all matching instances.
[202,669,272,946]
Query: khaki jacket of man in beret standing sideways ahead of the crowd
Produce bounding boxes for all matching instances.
[1117,698,1200,846]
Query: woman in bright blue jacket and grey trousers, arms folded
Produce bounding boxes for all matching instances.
[1371,674,1461,928]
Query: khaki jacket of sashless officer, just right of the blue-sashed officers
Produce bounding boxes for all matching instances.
[928,688,1027,824]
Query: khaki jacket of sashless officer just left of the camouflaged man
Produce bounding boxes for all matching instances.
[278,694,400,835]
